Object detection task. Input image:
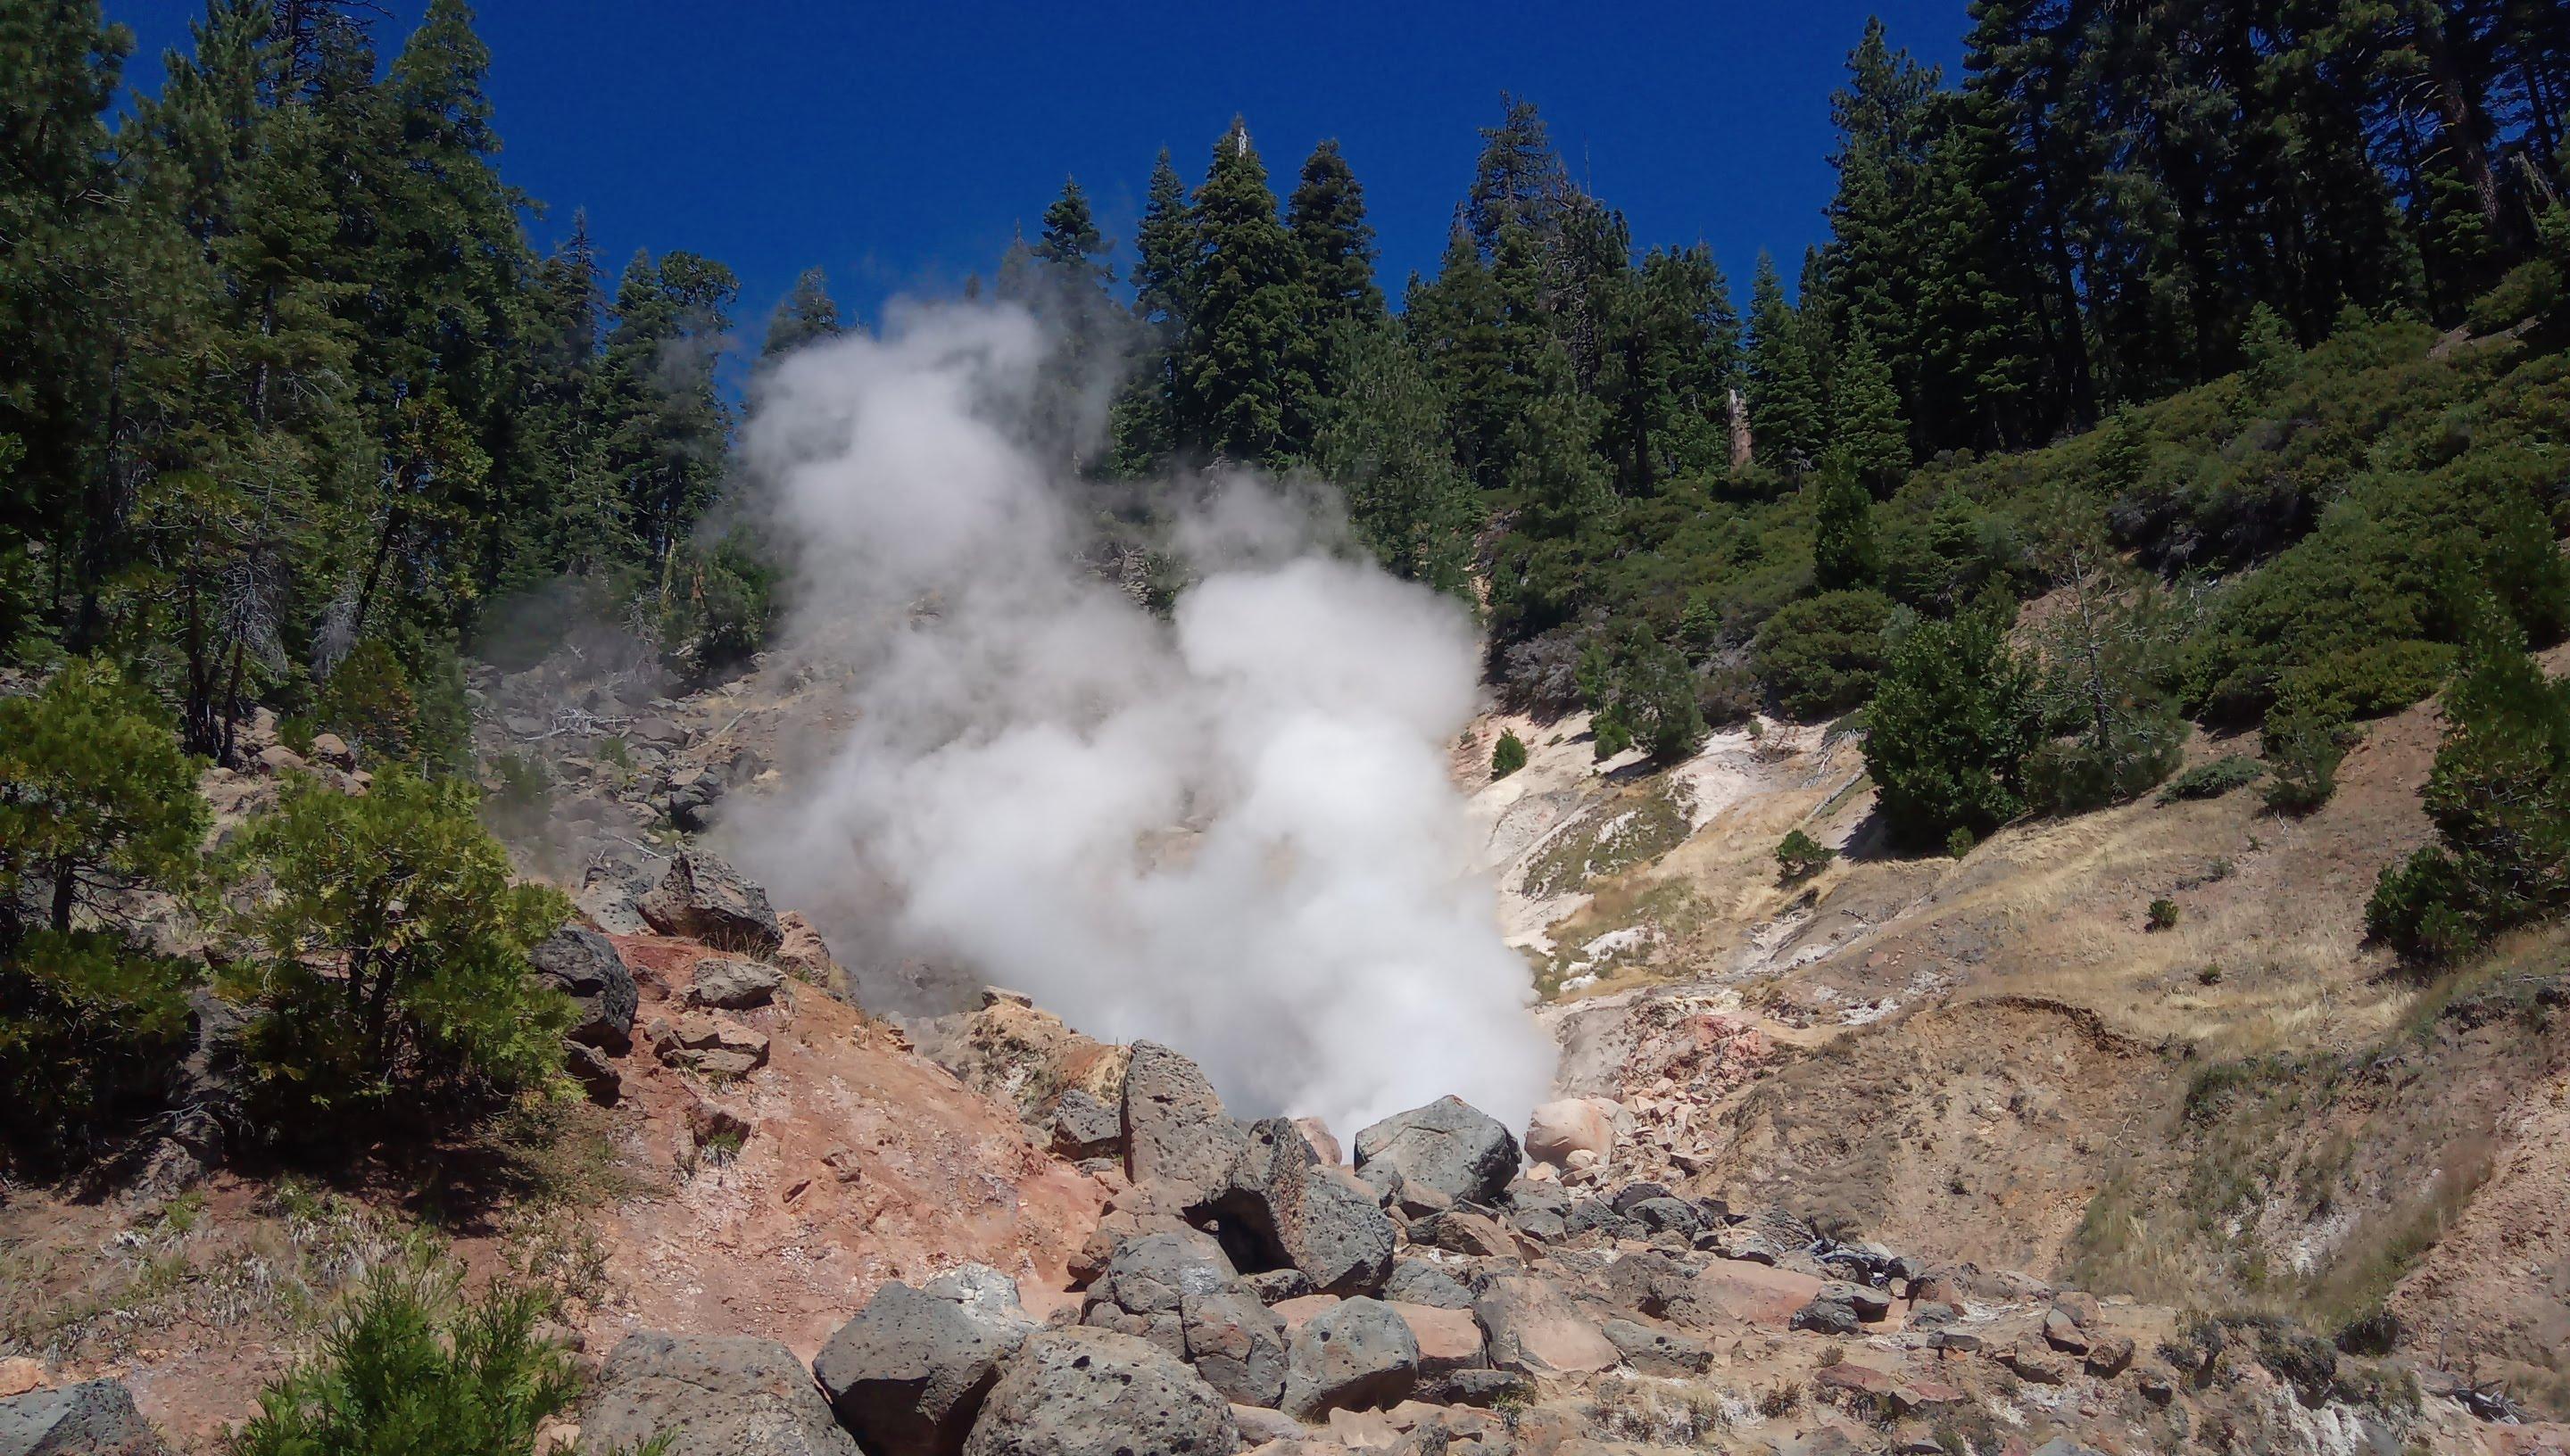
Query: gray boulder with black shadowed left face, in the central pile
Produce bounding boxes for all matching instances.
[1213,1117,1401,1295]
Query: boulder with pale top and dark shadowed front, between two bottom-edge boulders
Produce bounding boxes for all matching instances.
[812,1271,1036,1456]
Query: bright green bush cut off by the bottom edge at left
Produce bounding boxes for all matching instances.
[231,1255,581,1456]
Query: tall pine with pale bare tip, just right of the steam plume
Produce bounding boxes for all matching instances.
[1180,120,1314,465]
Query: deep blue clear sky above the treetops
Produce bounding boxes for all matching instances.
[105,0,1966,346]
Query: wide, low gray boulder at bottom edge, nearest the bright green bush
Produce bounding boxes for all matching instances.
[581,1333,858,1456]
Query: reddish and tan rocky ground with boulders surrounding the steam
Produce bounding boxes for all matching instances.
[0,644,2570,1456]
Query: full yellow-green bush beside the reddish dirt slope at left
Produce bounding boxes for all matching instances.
[228,768,570,1132]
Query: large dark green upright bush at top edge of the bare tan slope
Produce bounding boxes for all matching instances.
[1866,611,2041,845]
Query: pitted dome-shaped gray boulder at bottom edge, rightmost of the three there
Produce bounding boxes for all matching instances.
[964,1330,1241,1456]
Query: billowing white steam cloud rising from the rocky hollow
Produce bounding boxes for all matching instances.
[733,308,1553,1132]
